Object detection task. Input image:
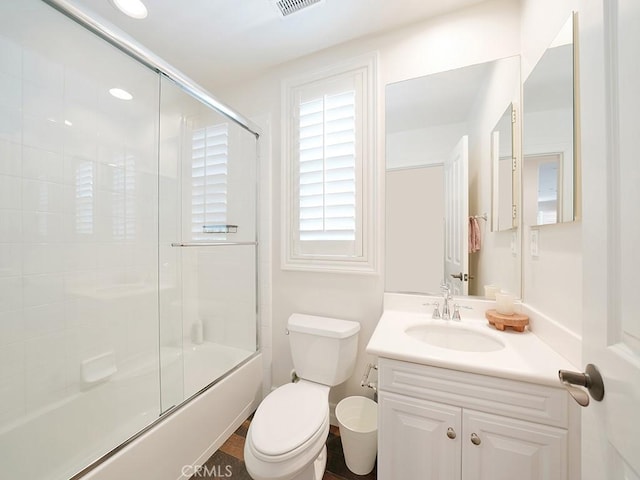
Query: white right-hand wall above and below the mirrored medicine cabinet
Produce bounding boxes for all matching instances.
[521,0,582,365]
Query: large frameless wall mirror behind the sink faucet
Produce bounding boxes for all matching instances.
[385,56,520,296]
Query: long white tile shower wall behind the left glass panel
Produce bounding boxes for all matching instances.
[0,21,162,425]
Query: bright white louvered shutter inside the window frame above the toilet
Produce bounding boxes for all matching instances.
[294,73,362,256]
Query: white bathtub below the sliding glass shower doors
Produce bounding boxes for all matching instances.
[0,343,262,480]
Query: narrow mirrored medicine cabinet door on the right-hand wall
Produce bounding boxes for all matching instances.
[522,16,577,226]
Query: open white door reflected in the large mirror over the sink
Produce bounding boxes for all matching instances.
[444,135,469,295]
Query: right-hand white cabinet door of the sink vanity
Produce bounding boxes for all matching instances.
[462,410,567,480]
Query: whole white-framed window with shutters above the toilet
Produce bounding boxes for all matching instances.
[283,56,376,272]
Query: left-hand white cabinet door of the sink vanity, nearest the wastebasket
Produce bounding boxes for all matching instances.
[378,392,461,480]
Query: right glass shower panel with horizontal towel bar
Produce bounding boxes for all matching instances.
[160,77,257,411]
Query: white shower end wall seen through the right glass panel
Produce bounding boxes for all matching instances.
[175,106,257,351]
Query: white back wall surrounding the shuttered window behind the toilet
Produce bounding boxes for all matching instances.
[217,0,520,408]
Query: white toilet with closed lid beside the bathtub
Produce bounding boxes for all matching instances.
[244,313,360,480]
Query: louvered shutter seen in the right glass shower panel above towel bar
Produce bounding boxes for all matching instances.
[191,123,229,240]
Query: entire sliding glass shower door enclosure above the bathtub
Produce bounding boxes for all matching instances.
[0,0,257,480]
